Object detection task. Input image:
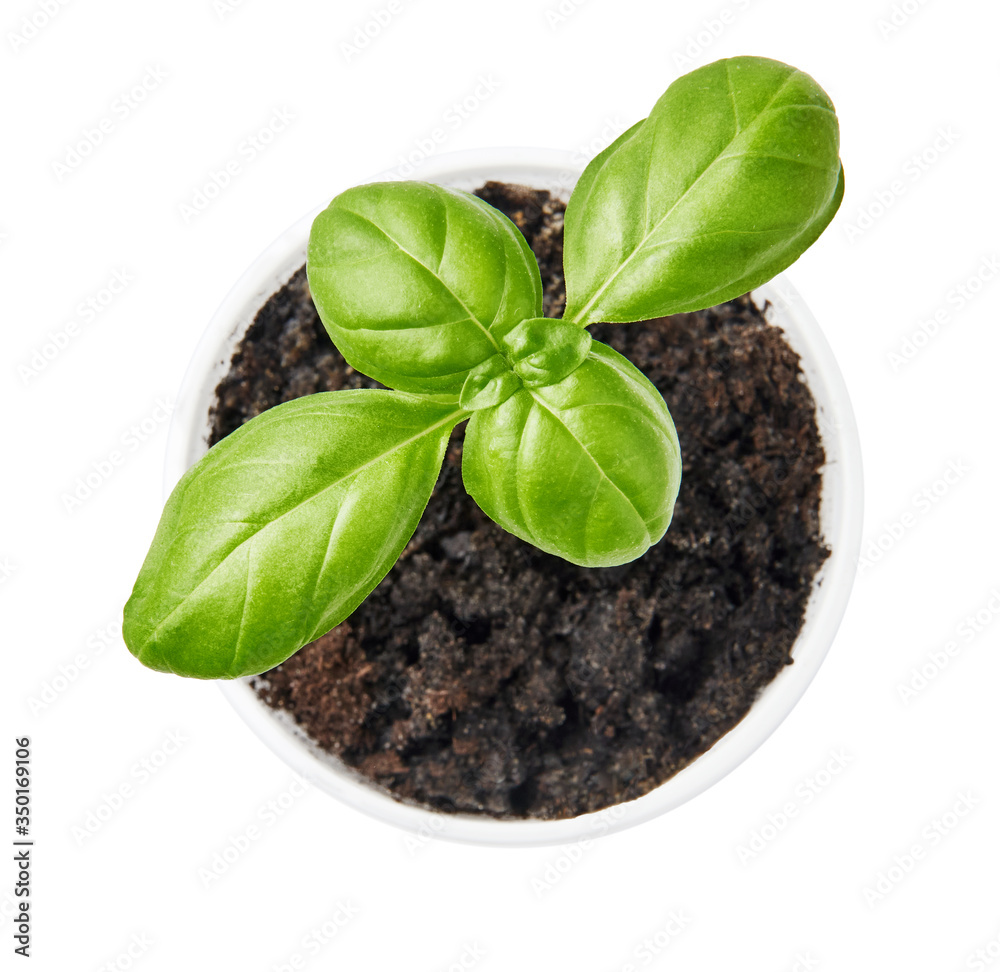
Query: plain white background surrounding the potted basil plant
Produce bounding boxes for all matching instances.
[0,0,1000,972]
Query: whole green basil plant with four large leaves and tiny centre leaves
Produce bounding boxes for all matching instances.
[124,57,844,678]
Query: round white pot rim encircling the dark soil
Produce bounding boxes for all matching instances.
[164,149,862,846]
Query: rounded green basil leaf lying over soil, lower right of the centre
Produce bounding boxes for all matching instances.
[462,341,681,567]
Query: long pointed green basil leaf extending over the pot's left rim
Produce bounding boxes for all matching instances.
[123,390,465,678]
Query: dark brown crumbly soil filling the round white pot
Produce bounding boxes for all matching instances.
[212,183,828,819]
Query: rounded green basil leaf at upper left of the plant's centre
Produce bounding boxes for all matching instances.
[307,182,542,396]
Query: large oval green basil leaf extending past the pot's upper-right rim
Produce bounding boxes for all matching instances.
[564,57,844,325]
